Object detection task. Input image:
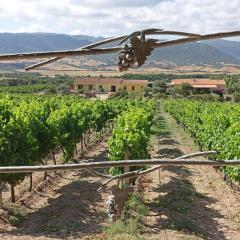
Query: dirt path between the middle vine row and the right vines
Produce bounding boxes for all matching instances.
[144,113,240,240]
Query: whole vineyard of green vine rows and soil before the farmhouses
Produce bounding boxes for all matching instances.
[0,93,240,240]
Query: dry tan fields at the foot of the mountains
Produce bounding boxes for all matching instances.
[12,60,240,77]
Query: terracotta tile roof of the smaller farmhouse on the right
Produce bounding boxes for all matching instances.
[171,78,226,88]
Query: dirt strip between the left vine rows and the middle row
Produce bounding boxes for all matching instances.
[0,142,108,240]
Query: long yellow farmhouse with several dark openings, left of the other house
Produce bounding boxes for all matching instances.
[72,78,148,93]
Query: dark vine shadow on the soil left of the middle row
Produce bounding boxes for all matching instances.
[4,150,107,239]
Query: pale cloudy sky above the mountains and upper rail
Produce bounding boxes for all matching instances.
[0,0,240,39]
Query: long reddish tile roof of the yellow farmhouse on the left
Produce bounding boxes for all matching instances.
[74,78,148,85]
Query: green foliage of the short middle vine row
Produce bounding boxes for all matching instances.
[108,101,156,175]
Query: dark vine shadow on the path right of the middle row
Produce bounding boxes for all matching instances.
[148,113,225,239]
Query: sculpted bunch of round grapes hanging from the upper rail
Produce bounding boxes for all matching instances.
[118,48,136,72]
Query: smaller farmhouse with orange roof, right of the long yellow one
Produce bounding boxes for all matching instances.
[170,78,226,92]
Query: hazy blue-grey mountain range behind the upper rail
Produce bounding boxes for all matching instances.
[0,33,240,67]
